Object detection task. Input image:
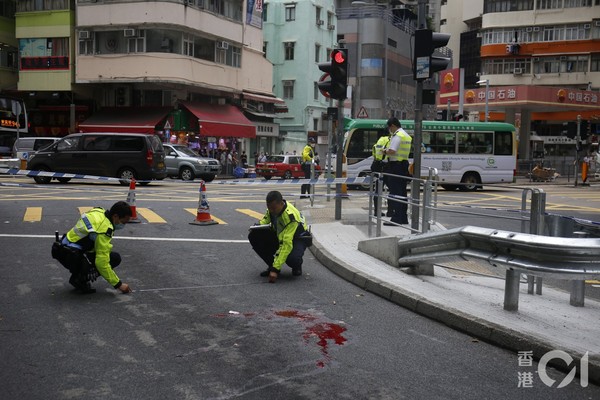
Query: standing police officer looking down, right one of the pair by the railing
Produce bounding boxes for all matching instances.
[384,117,412,225]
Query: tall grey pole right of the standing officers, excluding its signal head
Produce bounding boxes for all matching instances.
[410,0,427,231]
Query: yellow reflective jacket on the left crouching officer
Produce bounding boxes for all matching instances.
[67,207,120,287]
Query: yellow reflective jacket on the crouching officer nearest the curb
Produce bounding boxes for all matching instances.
[259,200,308,271]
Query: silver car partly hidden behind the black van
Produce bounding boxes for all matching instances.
[163,144,221,182]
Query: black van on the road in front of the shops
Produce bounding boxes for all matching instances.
[27,133,167,185]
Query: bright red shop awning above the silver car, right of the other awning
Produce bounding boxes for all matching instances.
[180,102,256,138]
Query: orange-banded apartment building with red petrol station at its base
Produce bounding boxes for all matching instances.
[439,0,600,159]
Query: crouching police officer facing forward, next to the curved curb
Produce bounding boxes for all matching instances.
[248,190,312,283]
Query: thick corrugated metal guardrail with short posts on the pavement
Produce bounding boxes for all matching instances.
[398,226,600,311]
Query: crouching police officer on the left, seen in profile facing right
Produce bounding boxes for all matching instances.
[52,201,132,293]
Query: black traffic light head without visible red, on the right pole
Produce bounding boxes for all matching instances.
[413,29,450,80]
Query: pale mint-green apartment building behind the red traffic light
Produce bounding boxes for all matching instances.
[262,0,337,155]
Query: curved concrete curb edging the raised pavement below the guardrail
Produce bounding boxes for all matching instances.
[310,240,600,384]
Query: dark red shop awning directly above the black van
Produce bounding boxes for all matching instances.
[79,107,173,133]
